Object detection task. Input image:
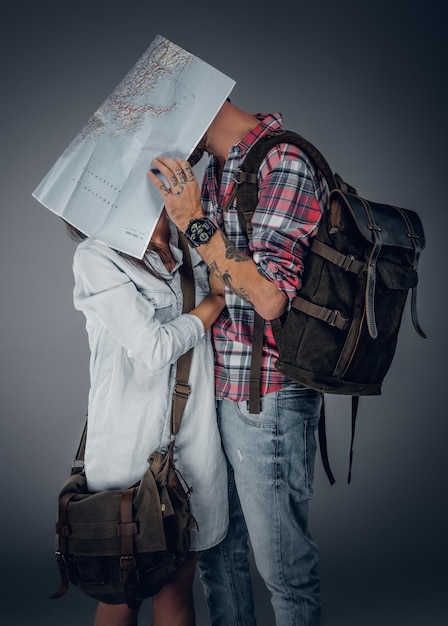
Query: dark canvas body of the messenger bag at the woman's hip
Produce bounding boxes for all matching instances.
[53,444,194,606]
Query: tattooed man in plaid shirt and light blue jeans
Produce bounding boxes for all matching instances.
[148,102,328,626]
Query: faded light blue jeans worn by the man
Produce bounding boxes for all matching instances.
[199,383,321,626]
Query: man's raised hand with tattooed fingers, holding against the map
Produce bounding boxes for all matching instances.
[148,156,204,232]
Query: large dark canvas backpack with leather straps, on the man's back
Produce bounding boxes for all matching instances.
[229,131,425,483]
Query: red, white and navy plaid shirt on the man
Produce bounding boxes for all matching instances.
[202,114,328,401]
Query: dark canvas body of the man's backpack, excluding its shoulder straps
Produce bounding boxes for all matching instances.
[274,190,424,395]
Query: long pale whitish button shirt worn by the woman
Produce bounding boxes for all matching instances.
[73,233,228,550]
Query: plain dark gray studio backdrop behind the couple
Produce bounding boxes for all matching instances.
[0,0,448,626]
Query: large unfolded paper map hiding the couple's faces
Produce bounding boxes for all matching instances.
[33,35,235,258]
